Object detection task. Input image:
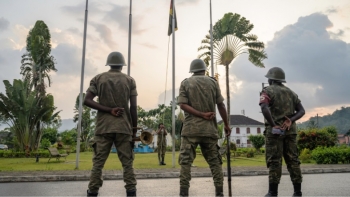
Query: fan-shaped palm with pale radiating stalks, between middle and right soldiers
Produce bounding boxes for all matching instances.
[198,13,267,123]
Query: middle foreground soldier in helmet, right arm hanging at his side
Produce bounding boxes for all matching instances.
[178,59,231,196]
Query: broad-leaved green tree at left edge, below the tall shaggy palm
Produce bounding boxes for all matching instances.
[0,79,59,153]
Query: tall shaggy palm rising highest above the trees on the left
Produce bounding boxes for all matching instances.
[21,20,57,94]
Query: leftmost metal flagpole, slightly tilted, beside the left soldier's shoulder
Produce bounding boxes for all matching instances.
[75,0,88,169]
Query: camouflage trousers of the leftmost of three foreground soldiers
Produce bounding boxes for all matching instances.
[89,133,136,193]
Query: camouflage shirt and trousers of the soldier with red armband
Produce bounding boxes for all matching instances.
[260,84,302,184]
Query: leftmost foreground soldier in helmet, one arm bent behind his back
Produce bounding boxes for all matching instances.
[84,52,137,196]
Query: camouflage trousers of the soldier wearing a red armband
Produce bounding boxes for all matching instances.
[265,134,303,184]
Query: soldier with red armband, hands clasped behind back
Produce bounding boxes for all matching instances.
[259,67,305,196]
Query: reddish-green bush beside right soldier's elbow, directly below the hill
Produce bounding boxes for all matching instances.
[297,127,338,150]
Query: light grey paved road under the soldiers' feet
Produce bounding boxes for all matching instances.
[0,173,350,196]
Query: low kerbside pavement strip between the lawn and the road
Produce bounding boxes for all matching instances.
[0,164,350,183]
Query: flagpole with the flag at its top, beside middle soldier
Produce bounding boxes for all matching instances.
[171,0,175,168]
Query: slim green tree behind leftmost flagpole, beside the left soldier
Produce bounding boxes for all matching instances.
[73,93,96,148]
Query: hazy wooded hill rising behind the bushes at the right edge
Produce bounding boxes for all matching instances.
[298,107,350,134]
